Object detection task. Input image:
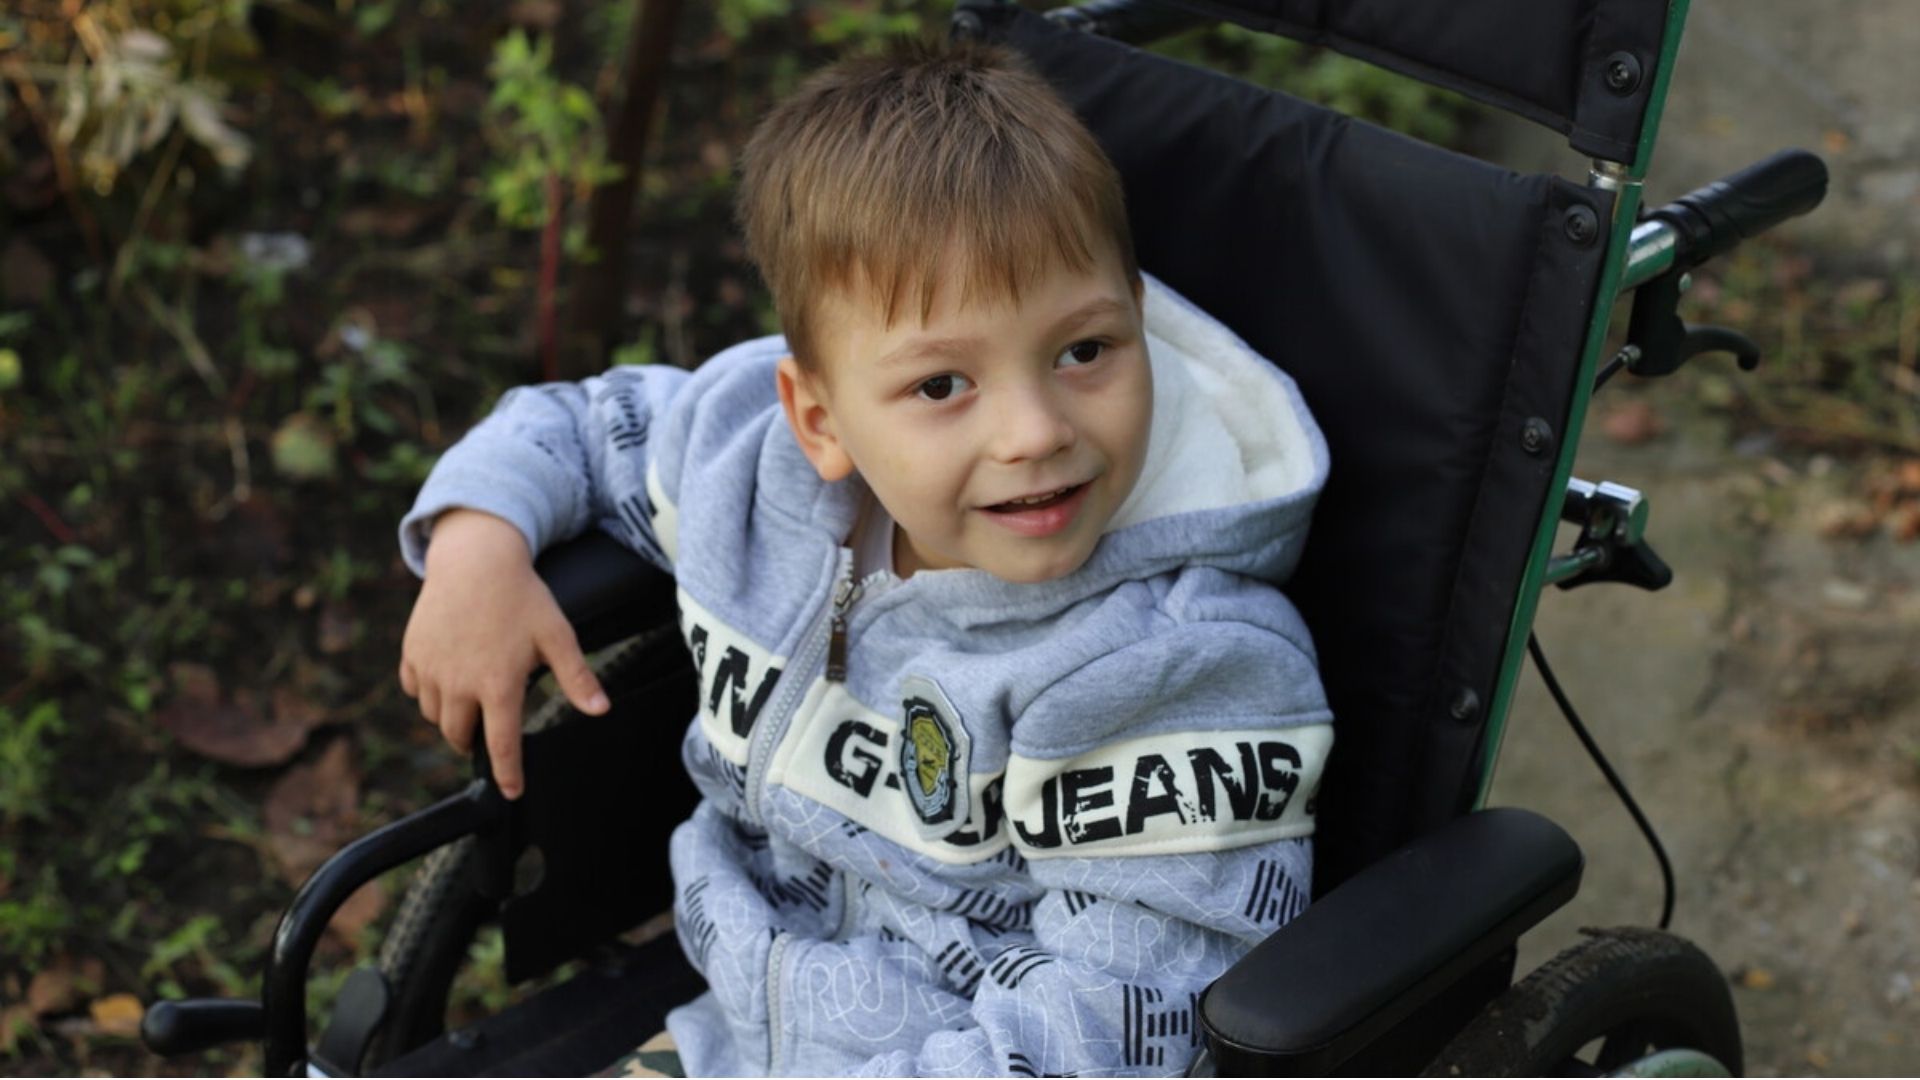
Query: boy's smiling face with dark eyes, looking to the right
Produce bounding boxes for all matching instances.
[780,245,1154,582]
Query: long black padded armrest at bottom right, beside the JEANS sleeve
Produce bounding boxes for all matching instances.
[1200,807,1582,1076]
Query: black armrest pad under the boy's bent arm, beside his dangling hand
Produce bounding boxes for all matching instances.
[534,528,674,651]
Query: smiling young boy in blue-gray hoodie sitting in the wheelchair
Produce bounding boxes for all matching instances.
[401,37,1332,1076]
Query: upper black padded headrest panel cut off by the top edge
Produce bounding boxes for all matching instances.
[1165,0,1668,163]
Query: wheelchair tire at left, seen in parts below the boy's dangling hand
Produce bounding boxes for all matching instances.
[361,626,672,1070]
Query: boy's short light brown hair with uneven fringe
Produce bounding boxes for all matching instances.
[739,40,1139,371]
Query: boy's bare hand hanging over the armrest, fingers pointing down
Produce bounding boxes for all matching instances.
[399,509,607,799]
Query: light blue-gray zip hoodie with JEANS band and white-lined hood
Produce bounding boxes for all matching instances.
[401,270,1332,1076]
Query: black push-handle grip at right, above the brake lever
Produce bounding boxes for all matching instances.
[1651,150,1826,267]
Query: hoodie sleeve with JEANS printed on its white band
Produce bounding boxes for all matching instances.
[825,611,1332,1076]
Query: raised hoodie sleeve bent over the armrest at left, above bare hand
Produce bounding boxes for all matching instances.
[399,365,689,577]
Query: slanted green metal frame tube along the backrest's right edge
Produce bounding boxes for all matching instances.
[1473,0,1690,809]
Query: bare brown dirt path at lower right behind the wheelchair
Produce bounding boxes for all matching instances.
[1494,401,1920,1076]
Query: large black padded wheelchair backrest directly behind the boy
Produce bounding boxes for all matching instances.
[981,8,1609,892]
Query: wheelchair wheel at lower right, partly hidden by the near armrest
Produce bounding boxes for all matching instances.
[1427,926,1741,1076]
